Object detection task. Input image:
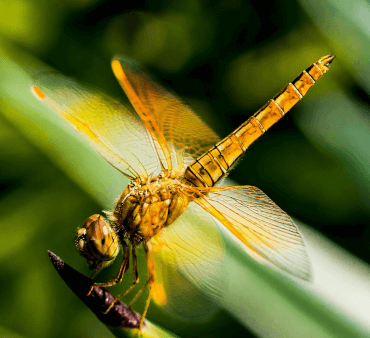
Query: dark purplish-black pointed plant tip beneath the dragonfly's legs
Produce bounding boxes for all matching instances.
[48,251,141,329]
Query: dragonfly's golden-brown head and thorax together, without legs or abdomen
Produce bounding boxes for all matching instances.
[76,172,190,270]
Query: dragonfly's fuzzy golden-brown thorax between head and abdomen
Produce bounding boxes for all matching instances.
[112,172,189,245]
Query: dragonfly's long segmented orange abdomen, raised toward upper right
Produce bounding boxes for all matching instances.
[184,54,335,187]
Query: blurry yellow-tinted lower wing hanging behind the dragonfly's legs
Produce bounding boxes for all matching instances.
[150,203,225,321]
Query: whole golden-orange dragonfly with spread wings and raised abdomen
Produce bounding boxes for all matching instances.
[31,54,335,328]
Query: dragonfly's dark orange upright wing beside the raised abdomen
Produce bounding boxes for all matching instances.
[112,57,219,169]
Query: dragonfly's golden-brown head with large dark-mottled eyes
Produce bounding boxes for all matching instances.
[76,214,119,270]
